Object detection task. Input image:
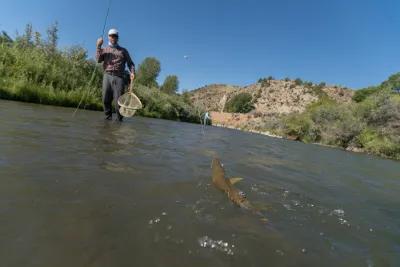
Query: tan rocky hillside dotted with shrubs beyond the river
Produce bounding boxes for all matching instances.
[190,80,354,115]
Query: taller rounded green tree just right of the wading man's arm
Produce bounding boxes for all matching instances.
[136,57,161,87]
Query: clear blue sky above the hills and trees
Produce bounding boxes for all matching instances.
[0,0,400,91]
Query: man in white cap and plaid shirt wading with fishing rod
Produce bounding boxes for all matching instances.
[96,29,135,121]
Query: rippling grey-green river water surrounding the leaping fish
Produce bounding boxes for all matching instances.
[0,101,400,267]
